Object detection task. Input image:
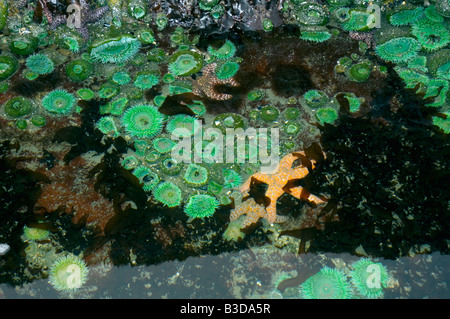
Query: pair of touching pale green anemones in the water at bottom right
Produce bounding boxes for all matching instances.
[300,258,389,299]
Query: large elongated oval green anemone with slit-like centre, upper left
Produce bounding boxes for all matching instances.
[91,35,141,63]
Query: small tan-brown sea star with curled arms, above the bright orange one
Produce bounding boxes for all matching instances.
[192,63,239,101]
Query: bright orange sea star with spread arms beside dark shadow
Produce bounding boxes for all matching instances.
[241,152,325,224]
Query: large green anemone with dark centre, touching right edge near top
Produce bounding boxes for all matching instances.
[411,18,450,52]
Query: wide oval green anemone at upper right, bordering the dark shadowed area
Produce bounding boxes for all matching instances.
[375,37,421,63]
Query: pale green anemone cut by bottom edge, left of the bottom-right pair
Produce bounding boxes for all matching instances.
[300,267,351,299]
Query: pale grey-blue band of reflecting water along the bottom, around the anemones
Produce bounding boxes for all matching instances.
[0,246,450,299]
